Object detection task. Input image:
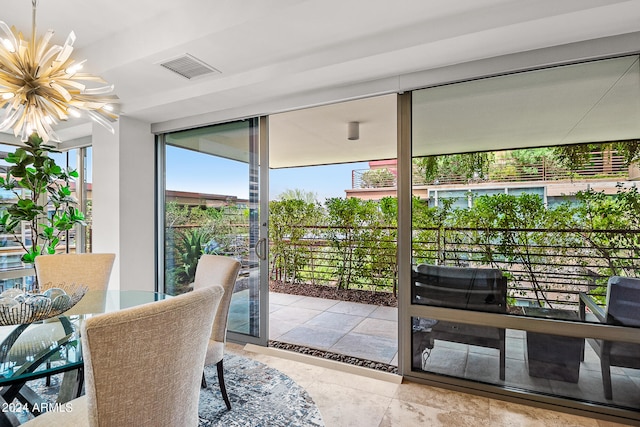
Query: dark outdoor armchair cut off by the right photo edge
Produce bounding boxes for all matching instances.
[579,276,640,399]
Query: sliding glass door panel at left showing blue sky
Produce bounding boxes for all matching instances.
[160,119,266,342]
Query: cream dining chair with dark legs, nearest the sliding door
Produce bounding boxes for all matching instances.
[193,255,241,409]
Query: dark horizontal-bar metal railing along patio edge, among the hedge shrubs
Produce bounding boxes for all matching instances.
[270,226,640,310]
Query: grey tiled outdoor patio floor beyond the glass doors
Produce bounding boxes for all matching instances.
[269,292,640,409]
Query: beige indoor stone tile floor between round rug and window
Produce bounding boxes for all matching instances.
[227,343,620,427]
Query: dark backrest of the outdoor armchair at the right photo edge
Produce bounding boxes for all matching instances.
[607,276,640,326]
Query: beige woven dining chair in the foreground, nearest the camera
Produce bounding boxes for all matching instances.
[24,286,224,427]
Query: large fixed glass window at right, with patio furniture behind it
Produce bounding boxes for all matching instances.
[407,56,640,413]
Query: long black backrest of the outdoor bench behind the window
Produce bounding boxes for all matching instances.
[412,264,507,312]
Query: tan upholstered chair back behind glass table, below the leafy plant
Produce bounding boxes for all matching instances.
[35,253,116,291]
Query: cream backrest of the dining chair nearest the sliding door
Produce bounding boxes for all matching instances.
[193,254,241,343]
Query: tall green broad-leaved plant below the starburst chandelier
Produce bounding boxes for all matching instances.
[0,133,85,280]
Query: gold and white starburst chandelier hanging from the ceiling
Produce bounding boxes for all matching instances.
[0,0,118,142]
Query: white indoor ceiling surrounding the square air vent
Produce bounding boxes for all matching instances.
[0,0,640,165]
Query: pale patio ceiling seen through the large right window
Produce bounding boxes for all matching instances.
[412,55,640,156]
